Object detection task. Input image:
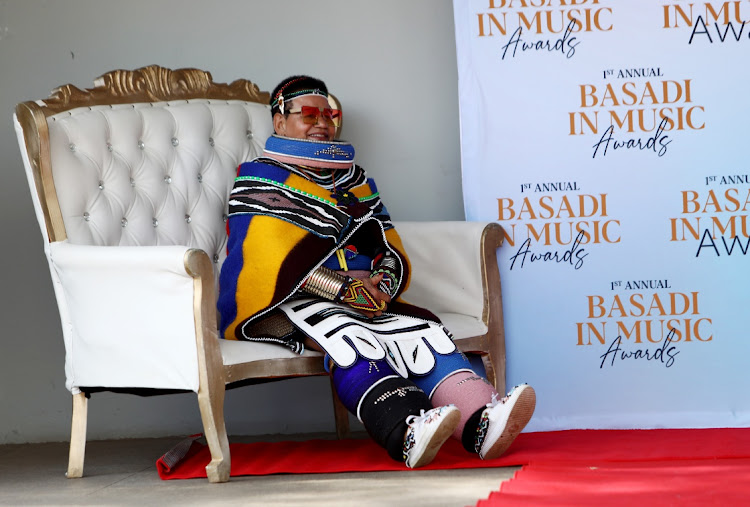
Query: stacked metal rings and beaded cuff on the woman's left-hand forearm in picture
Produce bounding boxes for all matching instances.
[301,266,385,312]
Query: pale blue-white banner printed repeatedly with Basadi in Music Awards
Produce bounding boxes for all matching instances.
[454,0,750,431]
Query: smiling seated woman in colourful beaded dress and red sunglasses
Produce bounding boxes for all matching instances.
[218,76,536,468]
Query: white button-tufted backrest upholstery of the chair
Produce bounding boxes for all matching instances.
[48,100,271,269]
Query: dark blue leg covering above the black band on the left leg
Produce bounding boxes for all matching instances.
[333,357,398,420]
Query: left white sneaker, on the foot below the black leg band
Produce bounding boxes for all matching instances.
[404,405,461,468]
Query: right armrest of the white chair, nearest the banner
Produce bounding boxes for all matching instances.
[394,222,502,324]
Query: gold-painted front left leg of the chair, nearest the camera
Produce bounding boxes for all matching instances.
[198,379,231,482]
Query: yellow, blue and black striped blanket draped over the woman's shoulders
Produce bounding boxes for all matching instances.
[218,158,409,341]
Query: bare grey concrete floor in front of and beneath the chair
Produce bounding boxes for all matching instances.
[0,435,518,507]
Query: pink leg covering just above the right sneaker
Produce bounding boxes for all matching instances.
[432,371,499,440]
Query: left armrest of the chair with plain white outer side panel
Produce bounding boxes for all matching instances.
[49,241,220,392]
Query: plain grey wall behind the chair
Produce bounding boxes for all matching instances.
[0,0,463,444]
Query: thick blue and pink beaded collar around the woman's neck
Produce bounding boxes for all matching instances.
[263,134,354,169]
